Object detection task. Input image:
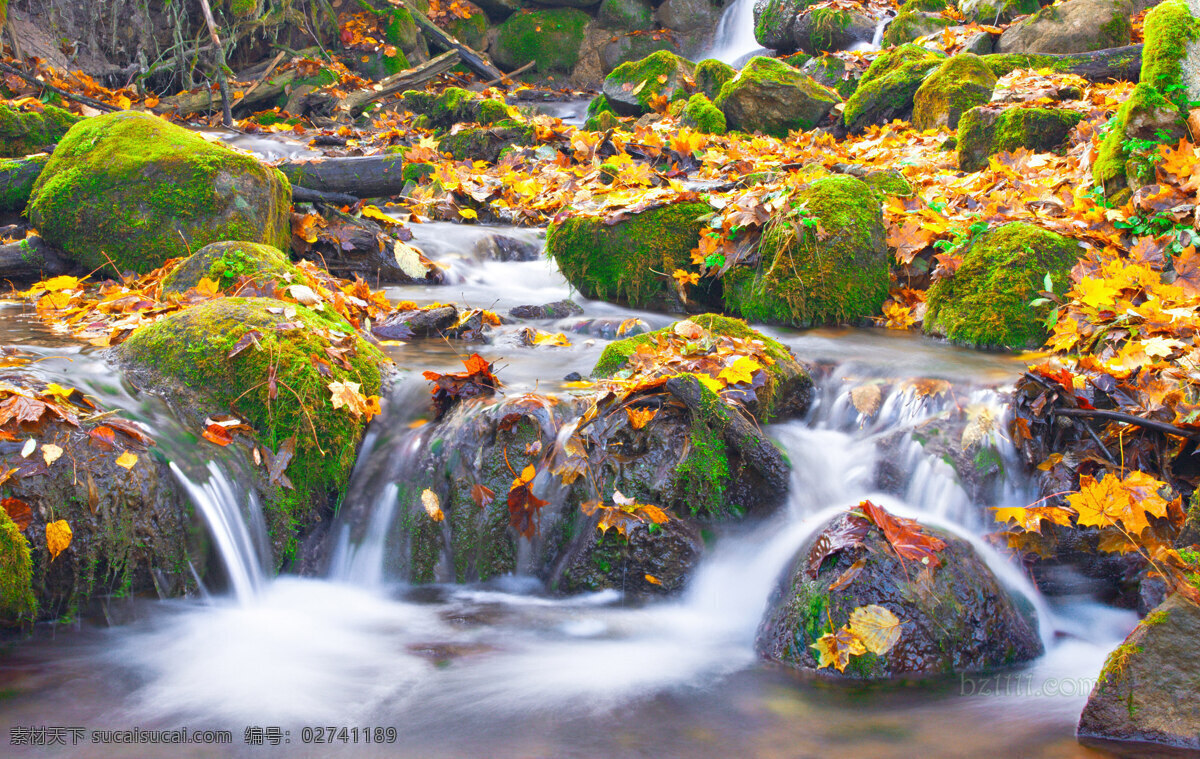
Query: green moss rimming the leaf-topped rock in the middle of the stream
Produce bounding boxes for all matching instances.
[592,313,806,423]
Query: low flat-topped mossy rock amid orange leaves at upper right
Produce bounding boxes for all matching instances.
[956,106,1082,172]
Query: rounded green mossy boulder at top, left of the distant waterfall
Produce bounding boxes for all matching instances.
[492,8,592,73]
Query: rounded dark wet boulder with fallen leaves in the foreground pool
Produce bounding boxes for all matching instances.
[756,514,1043,680]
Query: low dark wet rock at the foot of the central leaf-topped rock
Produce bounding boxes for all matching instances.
[550,513,704,596]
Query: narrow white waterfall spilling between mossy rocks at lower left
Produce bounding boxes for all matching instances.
[170,461,269,604]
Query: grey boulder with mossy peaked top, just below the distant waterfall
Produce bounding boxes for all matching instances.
[713,55,841,137]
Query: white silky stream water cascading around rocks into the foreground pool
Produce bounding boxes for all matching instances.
[0,225,1135,758]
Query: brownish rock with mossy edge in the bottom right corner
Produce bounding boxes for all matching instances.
[1079,594,1200,749]
